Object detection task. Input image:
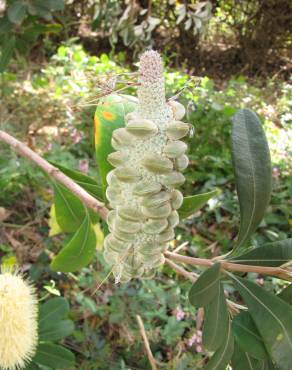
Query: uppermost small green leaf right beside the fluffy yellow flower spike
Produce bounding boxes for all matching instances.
[39,297,69,330]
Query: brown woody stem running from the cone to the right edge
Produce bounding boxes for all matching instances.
[164,252,292,281]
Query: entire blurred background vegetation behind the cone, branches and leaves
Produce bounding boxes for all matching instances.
[0,0,292,370]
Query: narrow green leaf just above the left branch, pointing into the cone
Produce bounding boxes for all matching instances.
[50,161,103,201]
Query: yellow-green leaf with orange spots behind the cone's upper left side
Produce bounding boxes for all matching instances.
[94,95,136,192]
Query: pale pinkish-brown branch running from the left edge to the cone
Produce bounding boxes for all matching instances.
[0,130,108,219]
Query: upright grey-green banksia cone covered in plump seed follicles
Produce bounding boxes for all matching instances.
[104,50,189,282]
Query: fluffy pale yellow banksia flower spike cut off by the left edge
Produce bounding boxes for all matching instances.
[0,271,38,370]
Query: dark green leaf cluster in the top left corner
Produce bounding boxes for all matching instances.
[0,0,64,73]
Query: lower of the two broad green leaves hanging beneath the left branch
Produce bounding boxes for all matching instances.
[51,214,96,272]
